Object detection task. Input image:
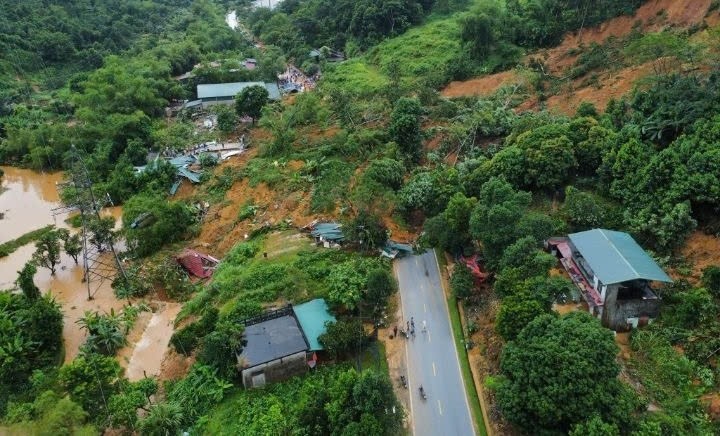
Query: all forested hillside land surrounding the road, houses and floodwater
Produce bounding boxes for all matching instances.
[0,0,720,436]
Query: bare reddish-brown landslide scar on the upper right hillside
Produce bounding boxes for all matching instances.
[442,0,720,115]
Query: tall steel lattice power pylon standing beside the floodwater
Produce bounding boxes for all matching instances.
[52,145,127,300]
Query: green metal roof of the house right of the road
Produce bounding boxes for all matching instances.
[569,229,672,285]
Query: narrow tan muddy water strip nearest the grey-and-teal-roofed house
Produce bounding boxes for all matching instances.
[119,303,182,381]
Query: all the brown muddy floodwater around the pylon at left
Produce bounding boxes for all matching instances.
[0,167,181,374]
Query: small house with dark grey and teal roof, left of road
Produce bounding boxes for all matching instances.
[237,299,335,388]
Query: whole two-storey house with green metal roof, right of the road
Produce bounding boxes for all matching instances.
[547,229,672,331]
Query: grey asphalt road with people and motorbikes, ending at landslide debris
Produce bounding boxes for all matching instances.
[395,251,474,436]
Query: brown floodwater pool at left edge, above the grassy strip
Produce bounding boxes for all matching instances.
[0,166,64,243]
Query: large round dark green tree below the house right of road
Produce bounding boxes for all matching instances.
[497,312,634,432]
